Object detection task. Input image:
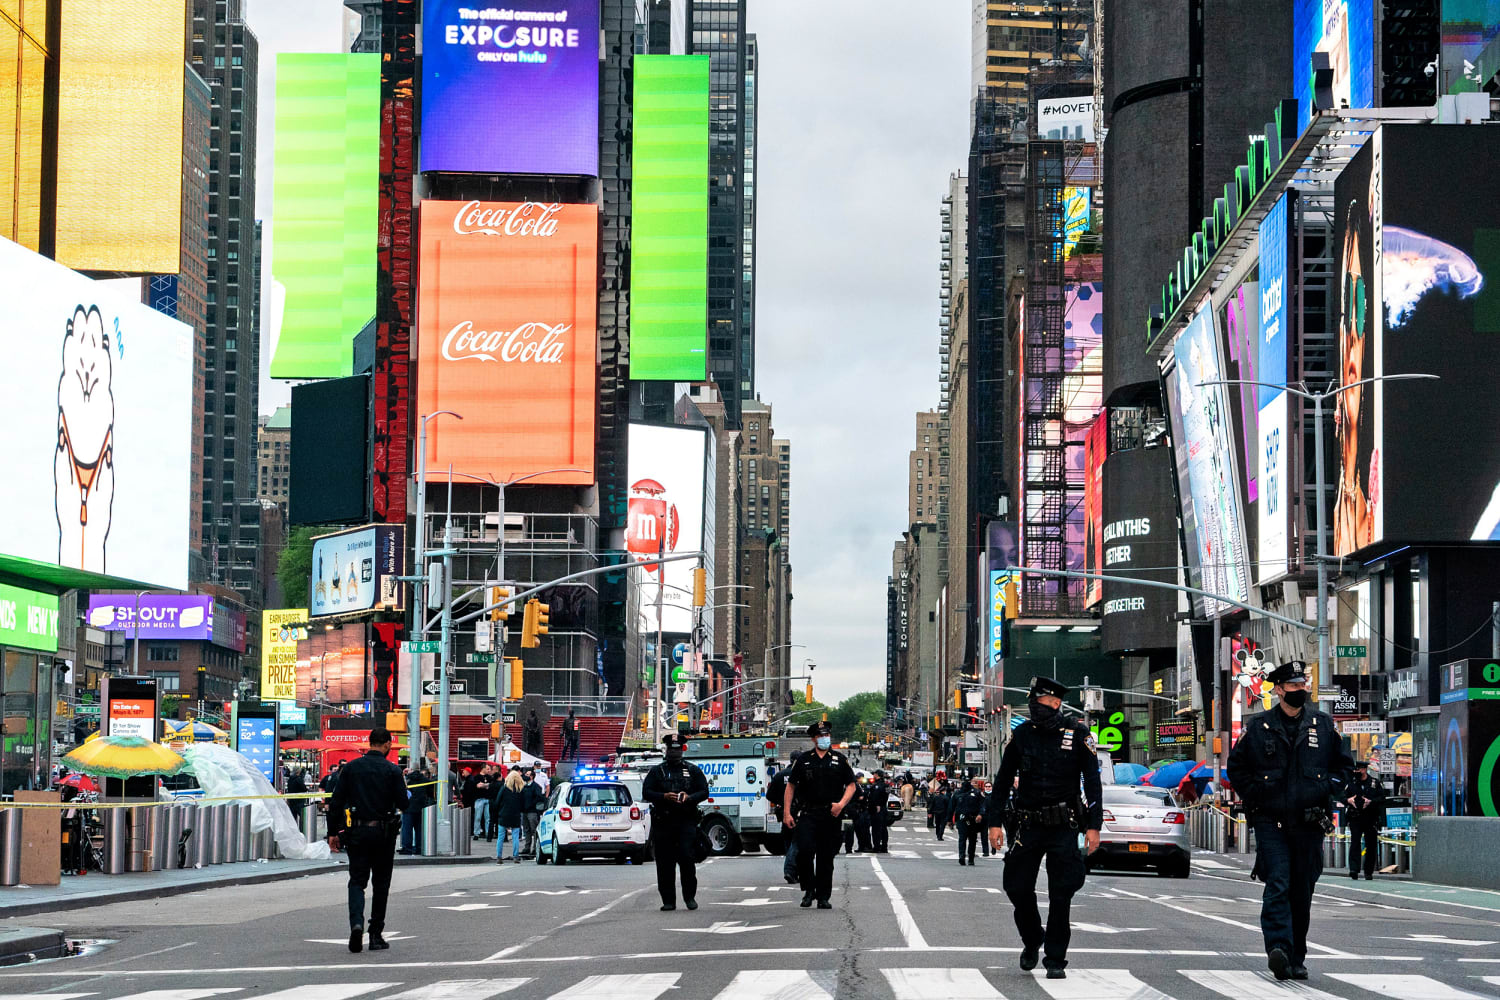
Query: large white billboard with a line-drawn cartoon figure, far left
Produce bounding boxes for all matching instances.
[0,238,194,589]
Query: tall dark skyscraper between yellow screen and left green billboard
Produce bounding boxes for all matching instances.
[189,0,263,607]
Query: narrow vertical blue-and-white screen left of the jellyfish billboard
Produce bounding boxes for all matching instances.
[1256,193,1293,583]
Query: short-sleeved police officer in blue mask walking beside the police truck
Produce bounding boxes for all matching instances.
[786,723,855,910]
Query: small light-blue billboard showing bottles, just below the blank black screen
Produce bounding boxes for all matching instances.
[308,525,407,618]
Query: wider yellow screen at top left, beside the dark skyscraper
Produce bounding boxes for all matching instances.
[57,0,188,274]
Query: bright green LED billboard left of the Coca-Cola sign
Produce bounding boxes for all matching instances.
[270,52,380,378]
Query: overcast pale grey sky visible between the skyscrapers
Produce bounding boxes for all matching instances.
[246,0,969,703]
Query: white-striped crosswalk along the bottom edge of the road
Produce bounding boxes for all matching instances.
[11,966,1500,1000]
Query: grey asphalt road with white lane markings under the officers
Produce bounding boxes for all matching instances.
[0,823,1500,1000]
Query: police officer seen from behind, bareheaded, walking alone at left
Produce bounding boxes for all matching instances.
[329,729,408,952]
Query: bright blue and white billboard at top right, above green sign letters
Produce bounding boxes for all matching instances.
[1292,0,1376,132]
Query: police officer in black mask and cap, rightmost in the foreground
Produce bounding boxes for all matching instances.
[1229,660,1353,979]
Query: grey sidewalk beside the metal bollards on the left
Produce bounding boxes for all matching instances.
[0,844,495,919]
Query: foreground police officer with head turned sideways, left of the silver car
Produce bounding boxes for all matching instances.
[984,678,1104,979]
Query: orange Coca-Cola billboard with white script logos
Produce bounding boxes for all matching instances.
[417,201,599,486]
